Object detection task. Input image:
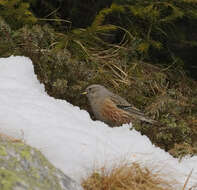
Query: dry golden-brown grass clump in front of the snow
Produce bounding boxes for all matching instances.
[82,163,173,190]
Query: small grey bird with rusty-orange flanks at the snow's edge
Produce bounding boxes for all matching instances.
[82,84,157,127]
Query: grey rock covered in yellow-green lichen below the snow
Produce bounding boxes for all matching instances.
[0,137,83,190]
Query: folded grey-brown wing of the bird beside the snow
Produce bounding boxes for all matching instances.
[110,94,145,116]
